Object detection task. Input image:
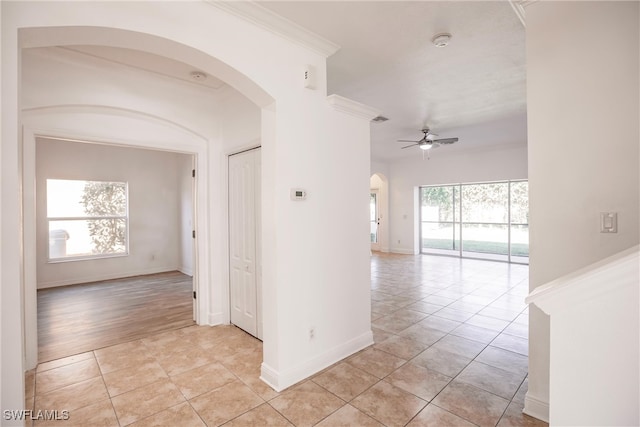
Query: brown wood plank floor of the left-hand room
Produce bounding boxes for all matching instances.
[38,271,194,363]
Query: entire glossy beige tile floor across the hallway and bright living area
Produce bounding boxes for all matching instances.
[25,254,546,427]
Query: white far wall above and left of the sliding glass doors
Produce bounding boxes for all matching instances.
[389,145,527,254]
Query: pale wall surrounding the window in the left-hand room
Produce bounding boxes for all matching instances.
[36,138,191,289]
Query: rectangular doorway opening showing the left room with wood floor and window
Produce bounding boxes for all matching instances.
[35,137,197,363]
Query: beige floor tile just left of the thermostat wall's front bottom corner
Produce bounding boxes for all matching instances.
[189,381,264,426]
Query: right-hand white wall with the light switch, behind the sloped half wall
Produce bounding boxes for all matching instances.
[525,1,640,418]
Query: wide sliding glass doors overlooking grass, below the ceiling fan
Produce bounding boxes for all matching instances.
[420,181,529,263]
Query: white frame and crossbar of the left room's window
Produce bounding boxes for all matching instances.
[45,178,129,264]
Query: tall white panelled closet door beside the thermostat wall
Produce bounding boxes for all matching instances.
[229,148,262,338]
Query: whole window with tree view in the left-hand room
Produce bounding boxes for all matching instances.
[47,179,128,261]
